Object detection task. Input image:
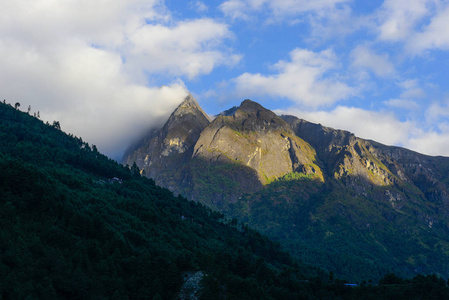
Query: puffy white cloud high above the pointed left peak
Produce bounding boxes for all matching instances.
[126,19,240,79]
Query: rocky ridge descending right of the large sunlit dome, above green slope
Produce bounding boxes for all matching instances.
[282,116,449,209]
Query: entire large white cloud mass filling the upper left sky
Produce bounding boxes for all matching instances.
[0,0,239,157]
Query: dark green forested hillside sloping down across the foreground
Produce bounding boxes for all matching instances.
[0,104,449,299]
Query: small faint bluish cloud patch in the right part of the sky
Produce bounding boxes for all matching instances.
[351,46,396,77]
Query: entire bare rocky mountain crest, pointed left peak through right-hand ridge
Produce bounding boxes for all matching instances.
[124,95,449,211]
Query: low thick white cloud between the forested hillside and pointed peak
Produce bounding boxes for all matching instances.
[0,36,187,158]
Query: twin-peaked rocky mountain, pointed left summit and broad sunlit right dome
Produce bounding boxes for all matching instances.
[122,96,322,208]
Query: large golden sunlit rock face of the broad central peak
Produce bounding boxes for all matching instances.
[193,100,322,184]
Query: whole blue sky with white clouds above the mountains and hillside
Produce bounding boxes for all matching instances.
[0,0,449,158]
